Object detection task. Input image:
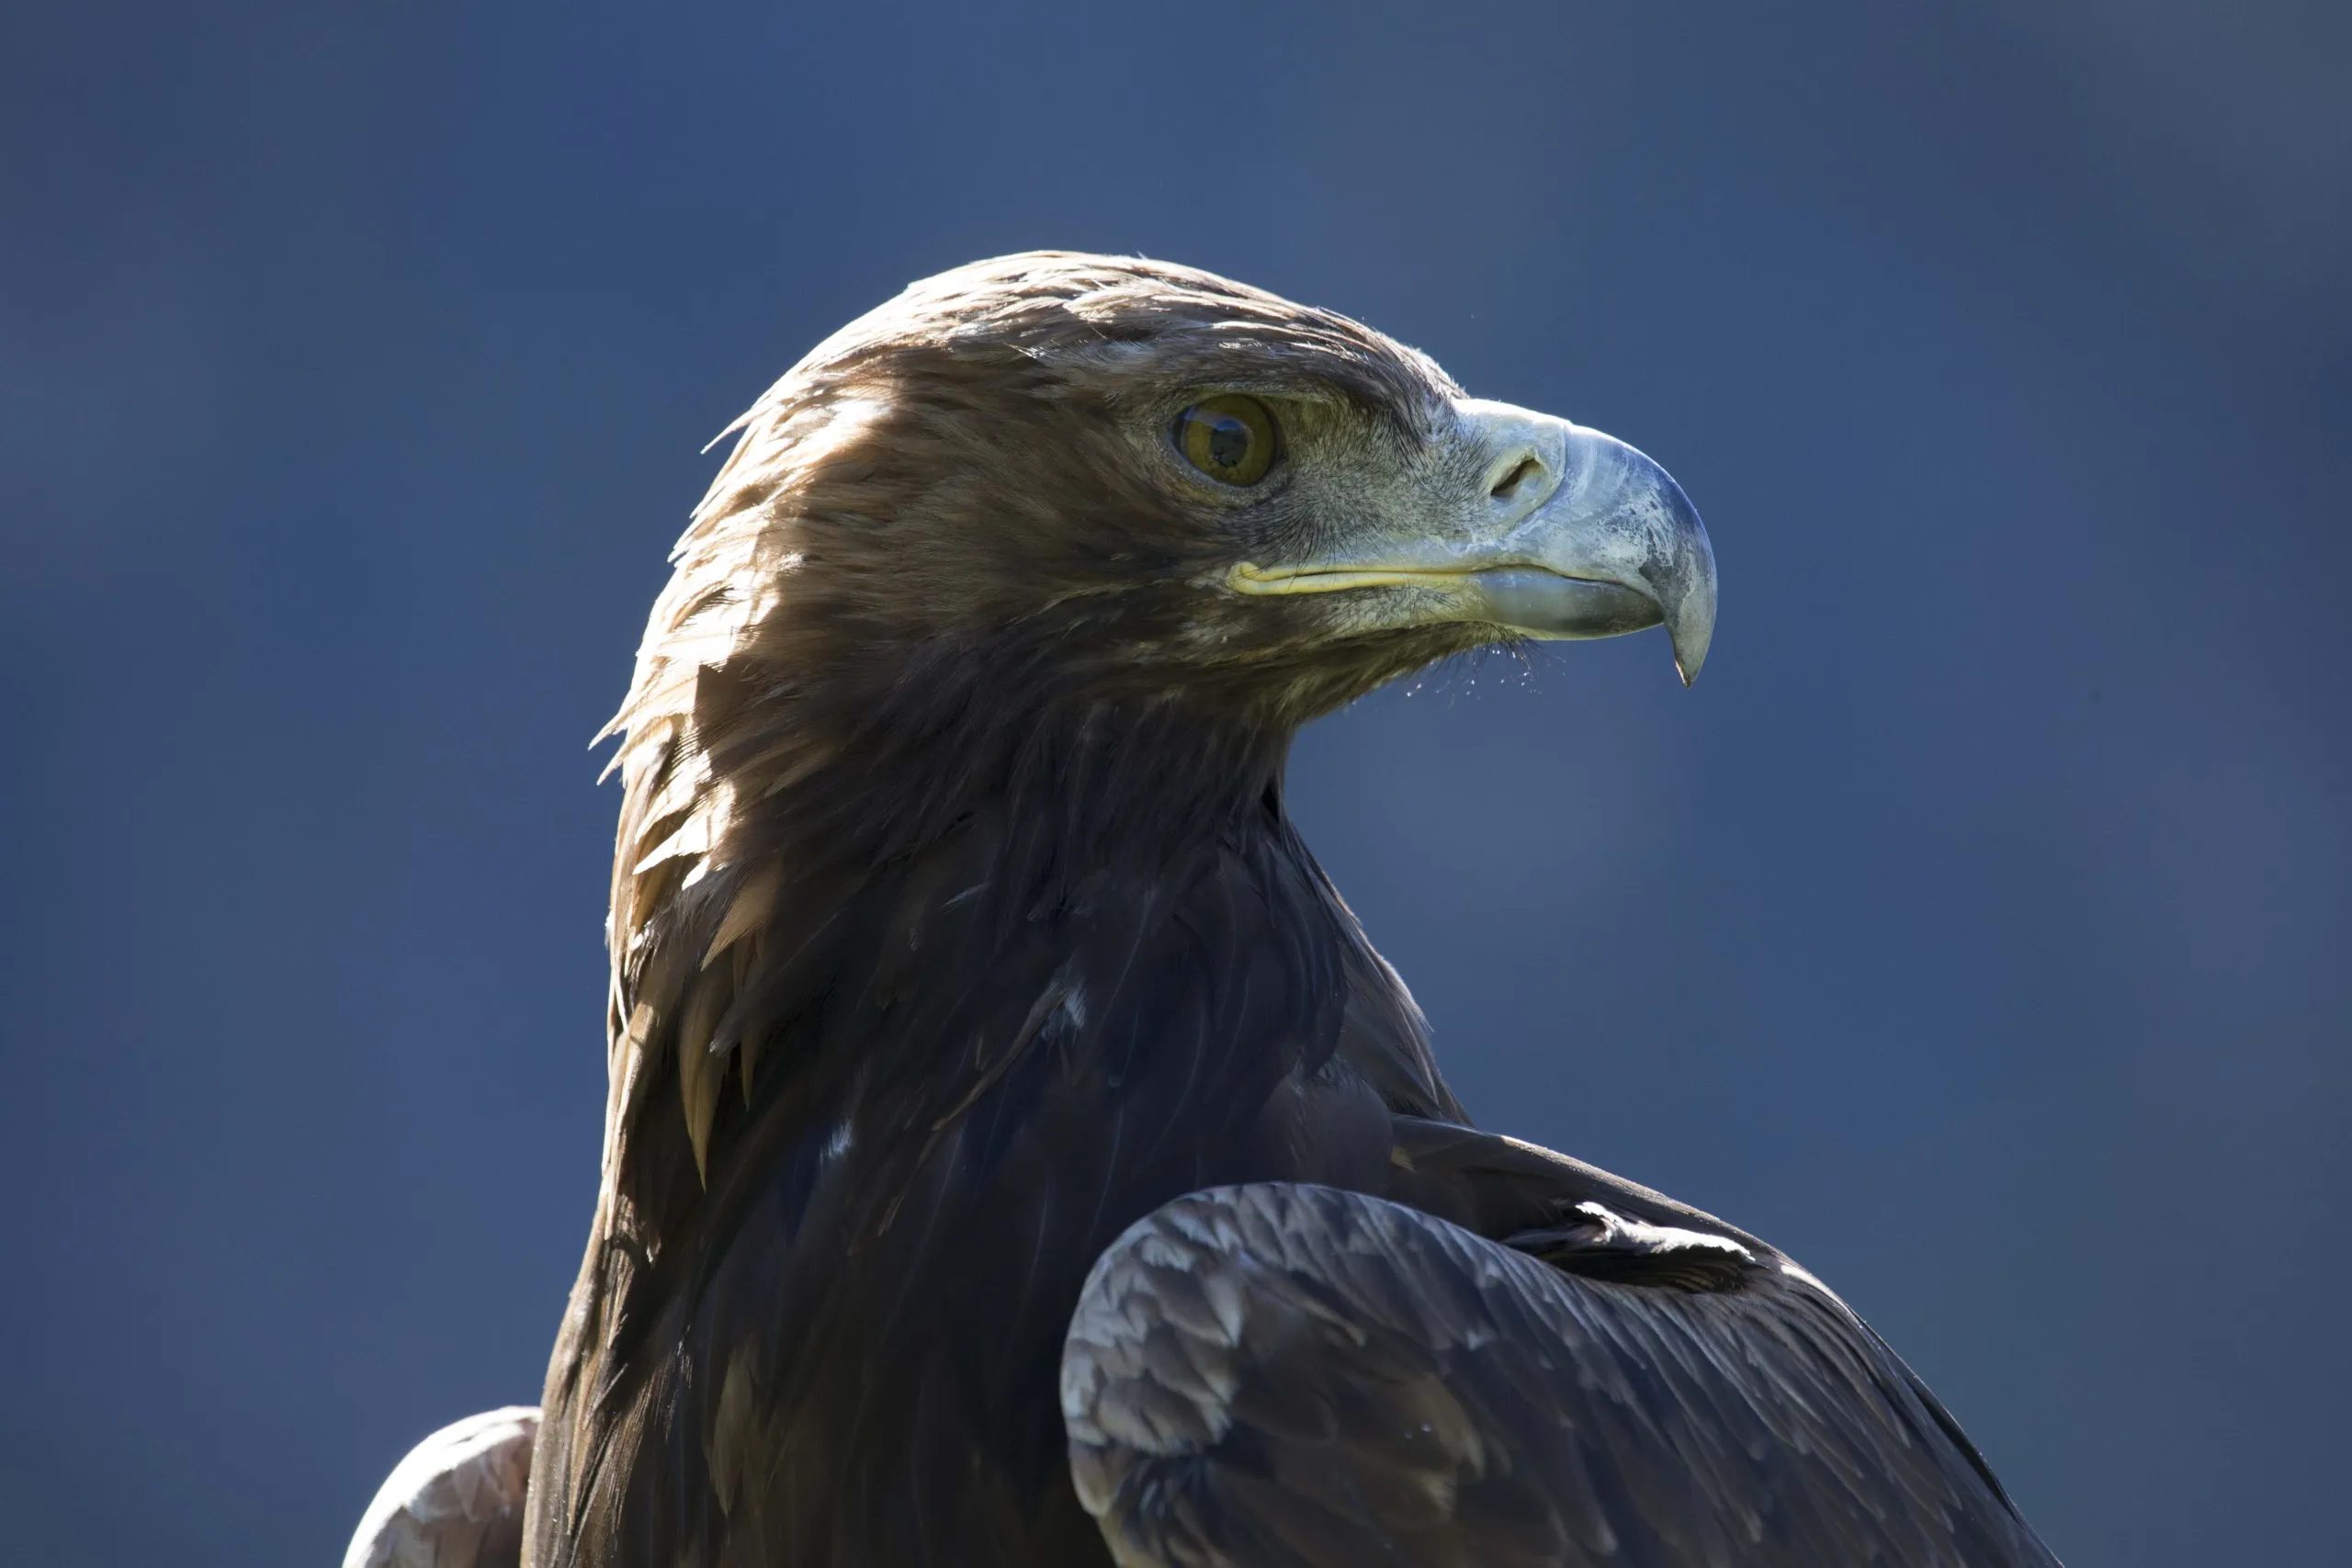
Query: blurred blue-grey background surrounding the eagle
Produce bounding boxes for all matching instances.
[0,0,2352,1568]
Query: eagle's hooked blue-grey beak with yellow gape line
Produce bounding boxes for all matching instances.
[1227,400,1714,684]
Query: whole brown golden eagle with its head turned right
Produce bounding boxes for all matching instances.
[353,252,2053,1568]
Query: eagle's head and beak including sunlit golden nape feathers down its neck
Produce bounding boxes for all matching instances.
[609,252,1714,1152]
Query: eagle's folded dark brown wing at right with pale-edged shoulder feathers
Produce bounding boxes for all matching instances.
[1063,1184,2055,1568]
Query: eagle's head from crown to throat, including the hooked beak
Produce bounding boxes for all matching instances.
[623,252,1714,751]
